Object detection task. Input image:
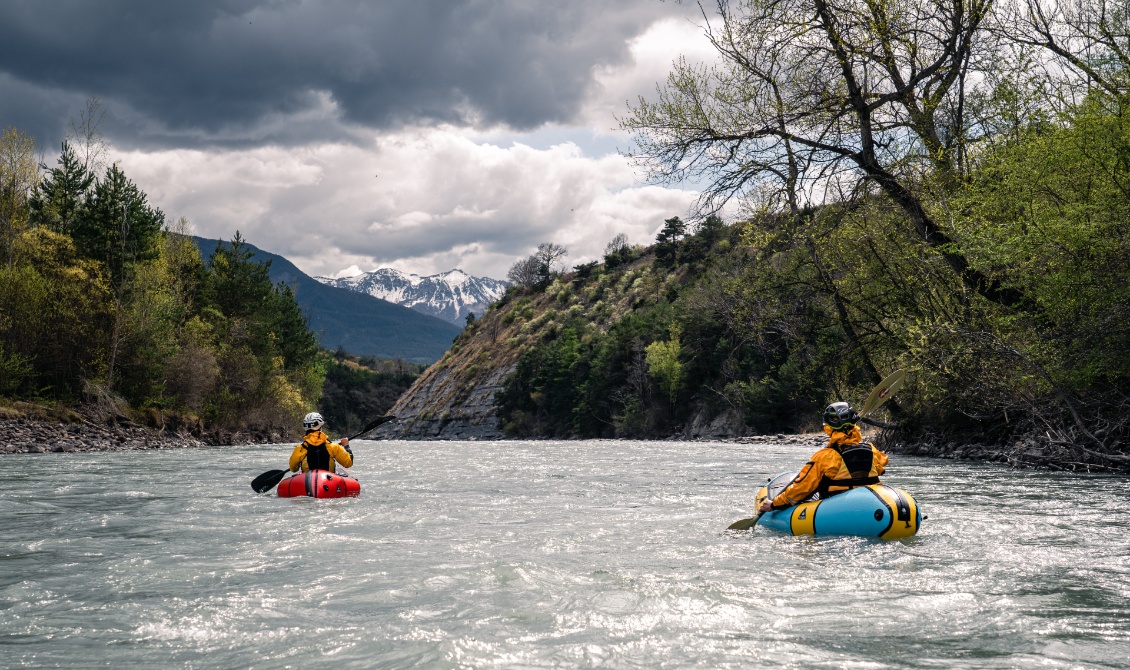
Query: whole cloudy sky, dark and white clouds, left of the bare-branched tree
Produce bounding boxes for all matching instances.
[0,0,711,278]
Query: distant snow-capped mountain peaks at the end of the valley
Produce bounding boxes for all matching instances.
[314,268,510,325]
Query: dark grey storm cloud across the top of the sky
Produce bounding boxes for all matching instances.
[0,0,688,146]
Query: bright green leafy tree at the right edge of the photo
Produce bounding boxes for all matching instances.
[931,90,1130,445]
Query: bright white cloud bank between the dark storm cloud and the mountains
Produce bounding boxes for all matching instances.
[120,129,696,277]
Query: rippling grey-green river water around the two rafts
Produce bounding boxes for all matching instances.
[0,442,1130,669]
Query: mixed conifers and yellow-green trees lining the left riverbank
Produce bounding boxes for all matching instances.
[0,120,418,443]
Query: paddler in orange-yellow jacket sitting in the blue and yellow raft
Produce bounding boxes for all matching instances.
[757,402,887,512]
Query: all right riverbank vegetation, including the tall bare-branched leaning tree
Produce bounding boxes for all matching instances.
[477,0,1130,468]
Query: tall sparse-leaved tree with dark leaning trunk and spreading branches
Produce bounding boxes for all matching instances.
[622,0,1024,306]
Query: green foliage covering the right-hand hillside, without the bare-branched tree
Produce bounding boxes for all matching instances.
[498,86,1130,450]
